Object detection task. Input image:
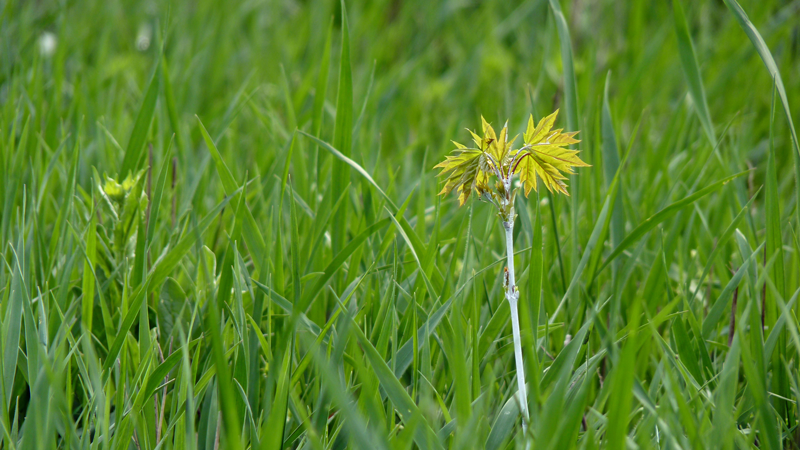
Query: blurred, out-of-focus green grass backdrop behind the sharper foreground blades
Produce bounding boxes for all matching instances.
[2,0,800,177]
